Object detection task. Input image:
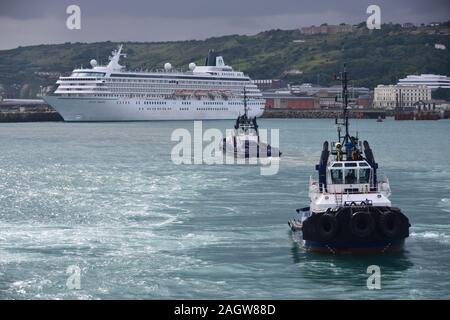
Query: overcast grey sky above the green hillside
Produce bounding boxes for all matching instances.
[0,0,450,49]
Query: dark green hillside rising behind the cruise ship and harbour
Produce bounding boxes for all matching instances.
[0,22,450,97]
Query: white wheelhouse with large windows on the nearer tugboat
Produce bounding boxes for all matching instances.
[327,160,374,193]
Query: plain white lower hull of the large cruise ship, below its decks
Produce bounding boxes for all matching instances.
[43,95,264,122]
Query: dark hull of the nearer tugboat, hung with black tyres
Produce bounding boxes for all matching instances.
[289,206,410,254]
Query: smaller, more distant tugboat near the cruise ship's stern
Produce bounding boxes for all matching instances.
[221,88,281,159]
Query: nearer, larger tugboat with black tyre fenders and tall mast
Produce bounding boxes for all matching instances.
[288,65,410,254]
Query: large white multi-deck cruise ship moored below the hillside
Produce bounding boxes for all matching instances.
[43,45,265,122]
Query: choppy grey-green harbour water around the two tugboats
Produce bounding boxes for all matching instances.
[0,119,450,299]
